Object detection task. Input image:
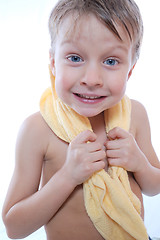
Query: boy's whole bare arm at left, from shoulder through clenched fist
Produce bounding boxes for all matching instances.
[3,112,105,238]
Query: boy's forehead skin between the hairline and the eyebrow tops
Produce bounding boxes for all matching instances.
[57,14,131,47]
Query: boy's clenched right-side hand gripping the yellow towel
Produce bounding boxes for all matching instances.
[105,127,145,172]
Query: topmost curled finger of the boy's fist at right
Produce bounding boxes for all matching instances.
[107,127,129,140]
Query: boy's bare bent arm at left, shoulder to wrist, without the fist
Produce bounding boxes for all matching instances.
[3,115,74,238]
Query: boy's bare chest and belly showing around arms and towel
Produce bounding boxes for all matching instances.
[42,113,144,240]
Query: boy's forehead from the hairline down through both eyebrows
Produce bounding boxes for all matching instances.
[56,14,133,56]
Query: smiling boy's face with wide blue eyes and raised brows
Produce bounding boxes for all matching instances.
[52,15,133,117]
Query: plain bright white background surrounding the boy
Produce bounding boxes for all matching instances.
[0,0,160,239]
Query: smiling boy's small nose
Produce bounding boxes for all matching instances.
[80,65,103,87]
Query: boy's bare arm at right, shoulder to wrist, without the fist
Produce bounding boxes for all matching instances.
[132,101,160,196]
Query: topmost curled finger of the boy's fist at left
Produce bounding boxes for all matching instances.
[73,130,97,144]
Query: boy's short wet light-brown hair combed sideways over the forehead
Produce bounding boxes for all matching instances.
[49,0,143,59]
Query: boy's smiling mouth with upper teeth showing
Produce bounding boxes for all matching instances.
[74,93,105,103]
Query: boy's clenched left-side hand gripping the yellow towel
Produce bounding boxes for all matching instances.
[64,130,106,186]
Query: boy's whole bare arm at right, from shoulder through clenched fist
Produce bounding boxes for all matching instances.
[106,101,160,195]
